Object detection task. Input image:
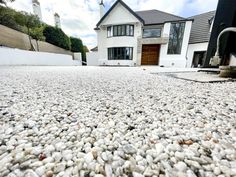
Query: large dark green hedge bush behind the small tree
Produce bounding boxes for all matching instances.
[43,26,71,50]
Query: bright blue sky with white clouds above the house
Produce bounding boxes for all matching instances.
[8,0,218,49]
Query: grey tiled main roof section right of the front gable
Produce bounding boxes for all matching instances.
[135,10,187,25]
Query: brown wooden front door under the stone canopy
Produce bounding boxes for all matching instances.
[141,44,160,65]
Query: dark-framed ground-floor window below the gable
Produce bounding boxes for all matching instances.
[108,47,133,60]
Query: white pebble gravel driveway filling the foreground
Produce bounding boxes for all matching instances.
[0,67,236,177]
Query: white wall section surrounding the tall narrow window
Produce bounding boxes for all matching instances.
[159,21,192,67]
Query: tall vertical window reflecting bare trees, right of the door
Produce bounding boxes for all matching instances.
[168,22,185,54]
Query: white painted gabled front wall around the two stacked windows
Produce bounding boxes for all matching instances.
[97,3,142,66]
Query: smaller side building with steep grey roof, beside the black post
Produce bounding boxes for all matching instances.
[187,11,216,67]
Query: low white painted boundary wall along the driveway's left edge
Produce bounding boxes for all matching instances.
[0,48,80,66]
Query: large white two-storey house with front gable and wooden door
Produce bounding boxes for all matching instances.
[95,0,193,67]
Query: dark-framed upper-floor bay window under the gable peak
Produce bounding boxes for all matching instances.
[107,25,134,37]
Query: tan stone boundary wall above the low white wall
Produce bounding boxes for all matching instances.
[0,25,73,55]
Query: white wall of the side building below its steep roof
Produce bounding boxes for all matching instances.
[187,42,208,68]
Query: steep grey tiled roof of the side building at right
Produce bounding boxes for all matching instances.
[189,11,215,44]
